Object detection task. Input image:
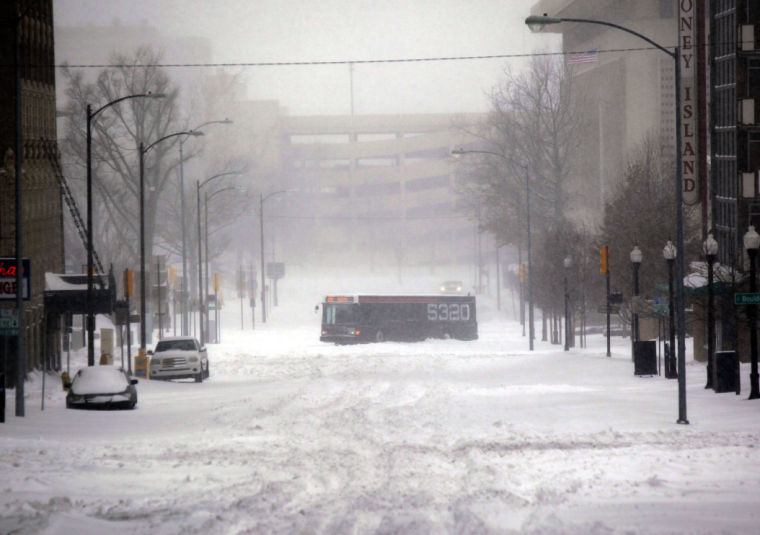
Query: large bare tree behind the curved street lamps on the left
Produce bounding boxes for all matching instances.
[61,47,188,276]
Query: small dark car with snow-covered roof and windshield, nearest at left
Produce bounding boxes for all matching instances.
[66,366,137,409]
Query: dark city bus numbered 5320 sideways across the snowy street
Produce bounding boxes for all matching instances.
[319,295,478,344]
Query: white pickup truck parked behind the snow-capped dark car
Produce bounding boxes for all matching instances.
[148,336,209,383]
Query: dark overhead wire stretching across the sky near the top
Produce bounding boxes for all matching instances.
[52,47,675,69]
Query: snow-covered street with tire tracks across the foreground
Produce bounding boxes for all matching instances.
[0,292,760,535]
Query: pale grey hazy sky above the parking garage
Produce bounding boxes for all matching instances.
[54,0,557,114]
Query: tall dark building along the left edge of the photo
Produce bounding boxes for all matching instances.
[0,0,63,385]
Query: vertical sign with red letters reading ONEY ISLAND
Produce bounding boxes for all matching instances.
[677,0,699,205]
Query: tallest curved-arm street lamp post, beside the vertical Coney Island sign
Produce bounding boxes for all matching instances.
[525,15,689,425]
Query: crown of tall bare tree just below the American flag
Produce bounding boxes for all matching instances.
[459,56,582,252]
